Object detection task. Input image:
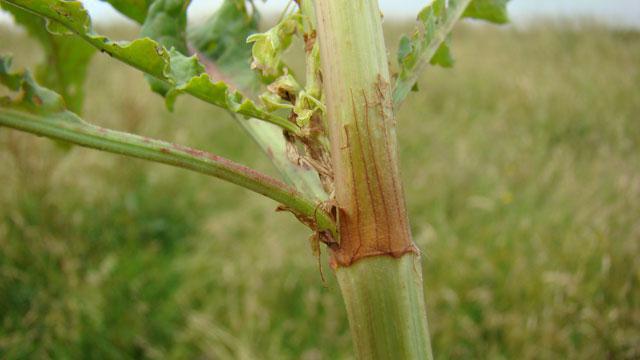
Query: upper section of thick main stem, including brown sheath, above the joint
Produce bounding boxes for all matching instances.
[315,0,418,267]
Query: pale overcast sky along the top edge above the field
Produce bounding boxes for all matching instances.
[0,0,640,28]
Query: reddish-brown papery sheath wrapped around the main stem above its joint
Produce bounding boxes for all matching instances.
[333,84,418,266]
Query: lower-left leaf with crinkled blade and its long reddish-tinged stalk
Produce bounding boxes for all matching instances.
[0,57,336,235]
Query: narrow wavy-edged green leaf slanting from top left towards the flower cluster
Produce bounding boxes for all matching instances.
[1,0,298,133]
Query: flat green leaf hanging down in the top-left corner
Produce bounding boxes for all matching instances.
[2,2,95,113]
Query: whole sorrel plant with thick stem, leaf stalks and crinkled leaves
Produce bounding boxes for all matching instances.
[0,0,507,359]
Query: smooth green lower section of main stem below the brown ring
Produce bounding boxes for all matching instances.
[336,254,431,359]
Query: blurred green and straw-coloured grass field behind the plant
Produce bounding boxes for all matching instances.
[0,19,640,359]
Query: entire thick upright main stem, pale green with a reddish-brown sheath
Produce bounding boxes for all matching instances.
[315,0,431,359]
